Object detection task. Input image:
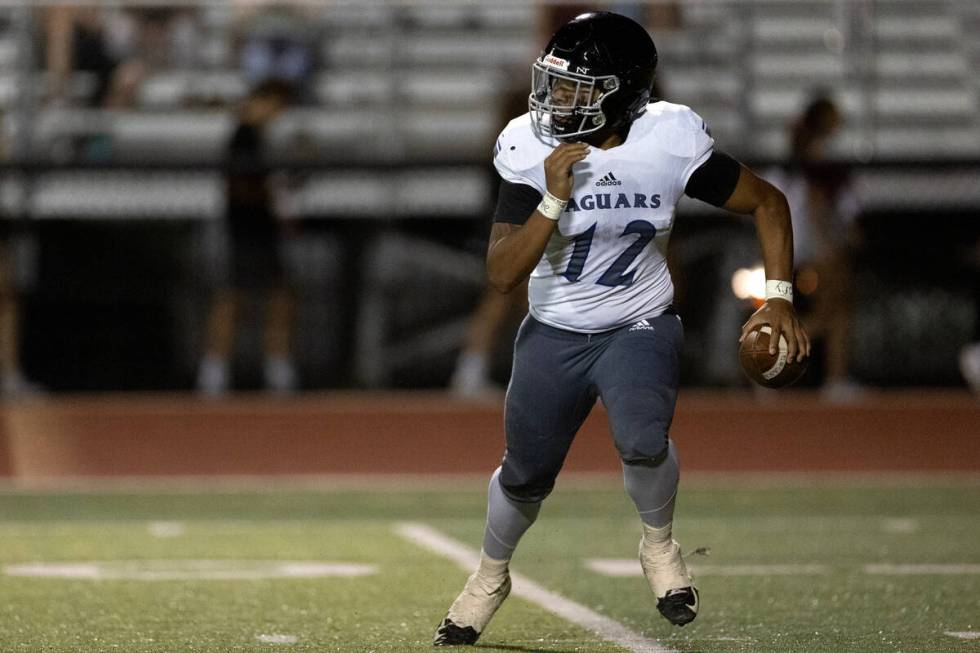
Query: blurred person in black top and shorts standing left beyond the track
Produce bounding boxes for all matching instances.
[197,80,297,396]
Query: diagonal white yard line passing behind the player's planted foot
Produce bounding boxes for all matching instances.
[395,522,677,653]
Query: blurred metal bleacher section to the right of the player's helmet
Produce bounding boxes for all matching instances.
[659,0,980,159]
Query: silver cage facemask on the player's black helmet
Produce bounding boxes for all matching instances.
[528,56,619,140]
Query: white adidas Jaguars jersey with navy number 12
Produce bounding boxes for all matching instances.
[494,102,714,333]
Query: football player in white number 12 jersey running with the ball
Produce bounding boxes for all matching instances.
[434,12,810,645]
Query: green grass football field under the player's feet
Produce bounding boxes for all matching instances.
[0,479,980,653]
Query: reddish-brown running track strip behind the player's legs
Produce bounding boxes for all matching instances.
[0,391,980,479]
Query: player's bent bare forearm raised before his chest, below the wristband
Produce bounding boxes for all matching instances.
[487,211,557,293]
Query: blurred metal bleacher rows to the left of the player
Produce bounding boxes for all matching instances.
[0,3,535,222]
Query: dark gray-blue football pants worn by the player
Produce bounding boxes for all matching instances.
[500,312,684,503]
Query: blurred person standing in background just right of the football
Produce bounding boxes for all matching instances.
[777,93,861,401]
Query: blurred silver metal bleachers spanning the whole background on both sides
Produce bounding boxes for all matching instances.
[0,0,980,218]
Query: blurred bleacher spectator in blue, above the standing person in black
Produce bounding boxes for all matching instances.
[236,5,318,102]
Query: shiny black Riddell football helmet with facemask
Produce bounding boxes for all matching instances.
[528,11,657,141]
